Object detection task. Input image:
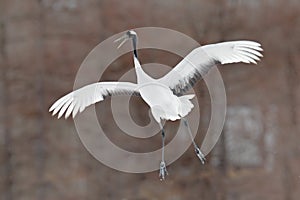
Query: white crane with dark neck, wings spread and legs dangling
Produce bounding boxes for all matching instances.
[49,30,263,180]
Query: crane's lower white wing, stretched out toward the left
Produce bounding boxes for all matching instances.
[49,82,139,118]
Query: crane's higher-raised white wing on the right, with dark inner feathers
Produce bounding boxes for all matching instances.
[158,41,263,96]
